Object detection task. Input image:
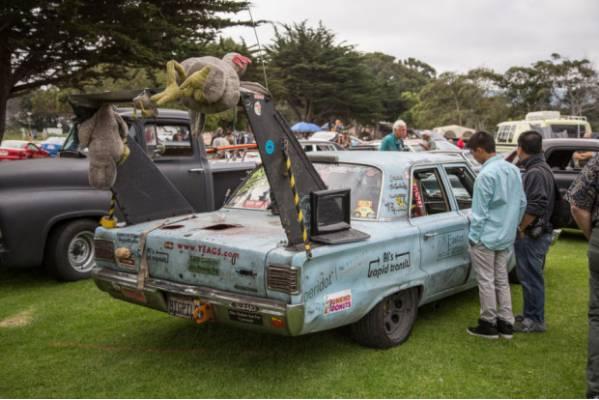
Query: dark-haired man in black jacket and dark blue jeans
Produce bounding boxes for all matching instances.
[514,131,556,333]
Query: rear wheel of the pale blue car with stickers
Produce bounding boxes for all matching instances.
[352,288,418,349]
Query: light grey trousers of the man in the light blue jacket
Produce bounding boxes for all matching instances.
[470,244,514,325]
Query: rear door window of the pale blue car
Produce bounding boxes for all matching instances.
[410,168,449,218]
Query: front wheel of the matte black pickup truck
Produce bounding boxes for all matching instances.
[45,219,98,282]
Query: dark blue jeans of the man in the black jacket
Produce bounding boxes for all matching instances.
[514,233,551,322]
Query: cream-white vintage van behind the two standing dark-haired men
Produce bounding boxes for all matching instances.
[495,111,591,151]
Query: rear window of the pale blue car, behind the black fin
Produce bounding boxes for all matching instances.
[227,163,383,219]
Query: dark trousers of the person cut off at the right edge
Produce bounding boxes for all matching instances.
[587,228,599,397]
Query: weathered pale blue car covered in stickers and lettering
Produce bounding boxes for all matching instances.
[92,151,513,348]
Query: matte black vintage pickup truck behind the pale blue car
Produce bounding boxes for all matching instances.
[0,105,256,281]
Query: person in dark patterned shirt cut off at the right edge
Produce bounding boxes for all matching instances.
[565,155,599,399]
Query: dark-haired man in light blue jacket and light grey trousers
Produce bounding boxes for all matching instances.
[467,131,526,339]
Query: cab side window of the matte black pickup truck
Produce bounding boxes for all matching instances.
[144,123,193,159]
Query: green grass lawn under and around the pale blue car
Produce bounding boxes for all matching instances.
[0,235,588,398]
